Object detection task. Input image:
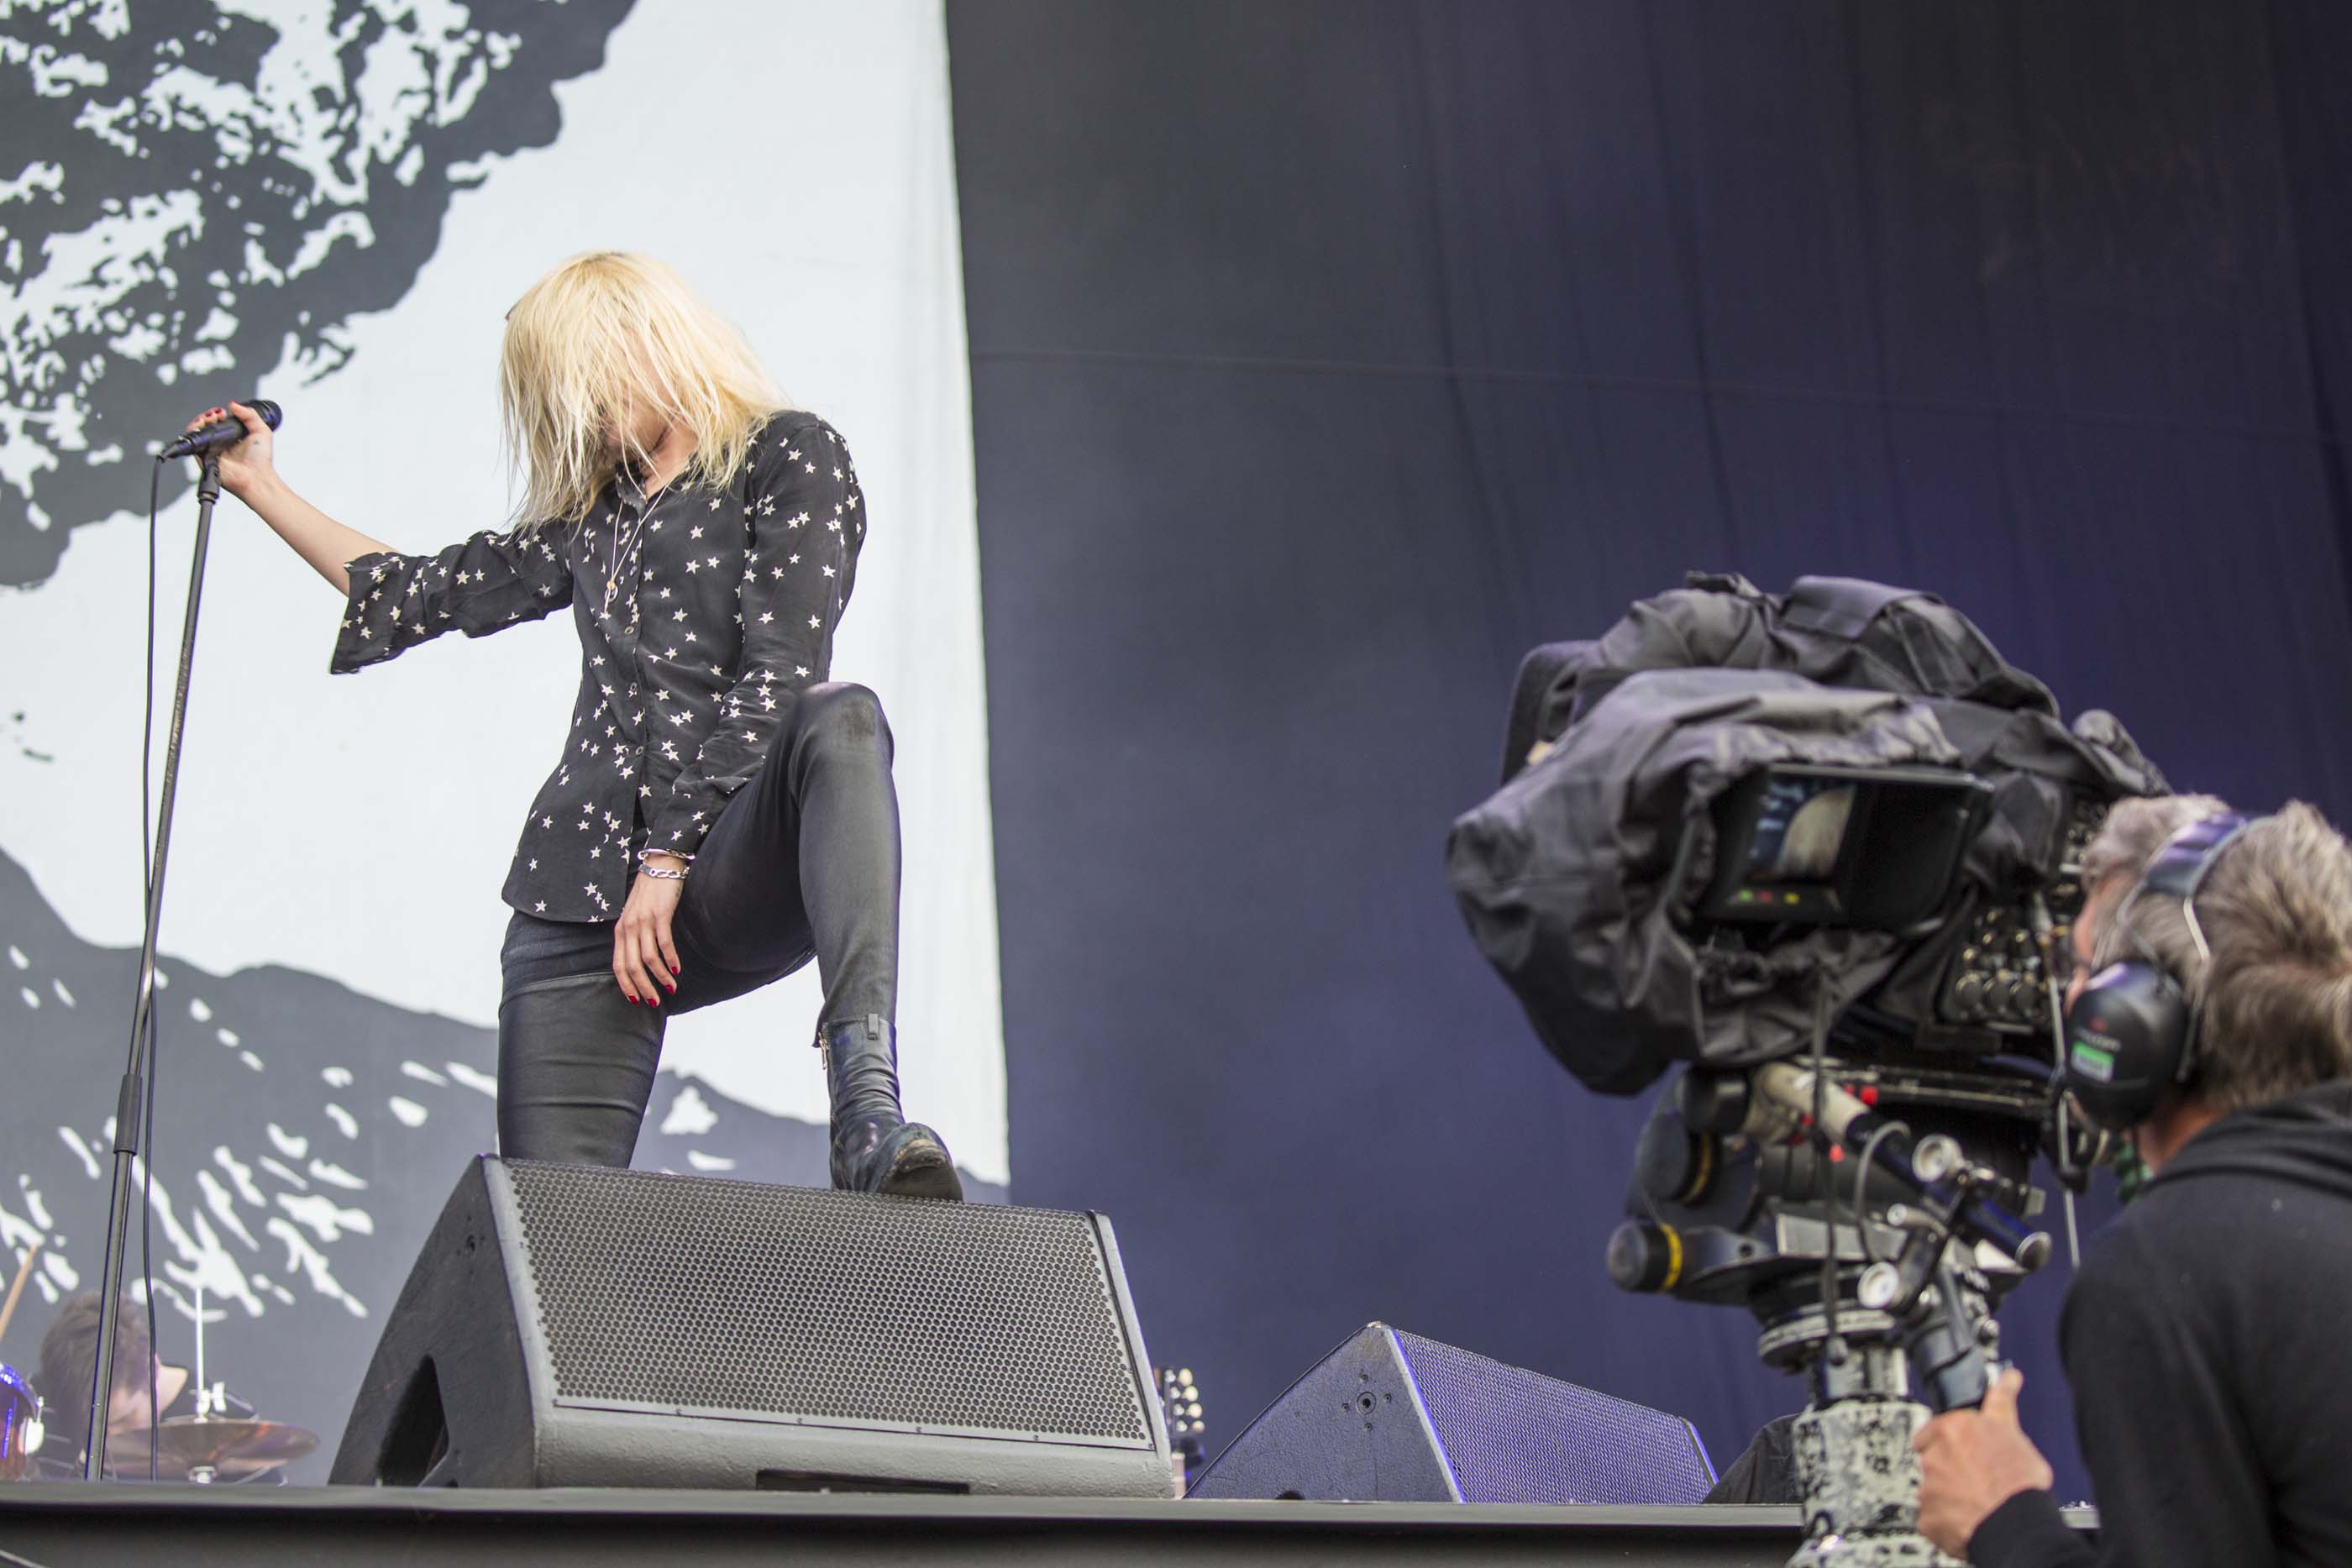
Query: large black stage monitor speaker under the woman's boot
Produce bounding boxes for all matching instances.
[329,1156,1169,1497]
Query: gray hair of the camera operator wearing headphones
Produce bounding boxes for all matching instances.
[2082,794,2352,1112]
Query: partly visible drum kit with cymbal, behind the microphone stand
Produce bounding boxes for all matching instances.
[0,1241,318,1486]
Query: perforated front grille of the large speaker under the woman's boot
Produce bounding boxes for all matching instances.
[506,1162,1150,1445]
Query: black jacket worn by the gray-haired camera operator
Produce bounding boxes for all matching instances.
[1969,1082,2352,1568]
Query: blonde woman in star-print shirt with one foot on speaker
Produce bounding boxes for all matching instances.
[191,252,962,1199]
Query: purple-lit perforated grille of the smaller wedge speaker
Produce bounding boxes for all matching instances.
[1397,1333,1714,1502]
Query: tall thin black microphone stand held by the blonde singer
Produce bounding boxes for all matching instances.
[82,447,221,1481]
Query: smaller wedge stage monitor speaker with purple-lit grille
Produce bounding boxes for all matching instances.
[1190,1324,1714,1504]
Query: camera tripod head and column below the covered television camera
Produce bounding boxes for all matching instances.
[1609,1056,2051,1568]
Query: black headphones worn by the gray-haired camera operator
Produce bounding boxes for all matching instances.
[2061,811,2258,1133]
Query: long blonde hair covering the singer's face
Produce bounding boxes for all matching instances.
[499,252,793,532]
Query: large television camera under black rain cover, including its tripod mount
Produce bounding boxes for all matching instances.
[1449,579,2164,1565]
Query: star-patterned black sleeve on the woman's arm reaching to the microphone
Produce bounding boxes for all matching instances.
[327,529,571,674]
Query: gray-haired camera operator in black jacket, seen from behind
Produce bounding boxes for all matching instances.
[1914,797,2352,1568]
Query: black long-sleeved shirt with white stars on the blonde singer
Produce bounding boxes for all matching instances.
[329,409,865,921]
